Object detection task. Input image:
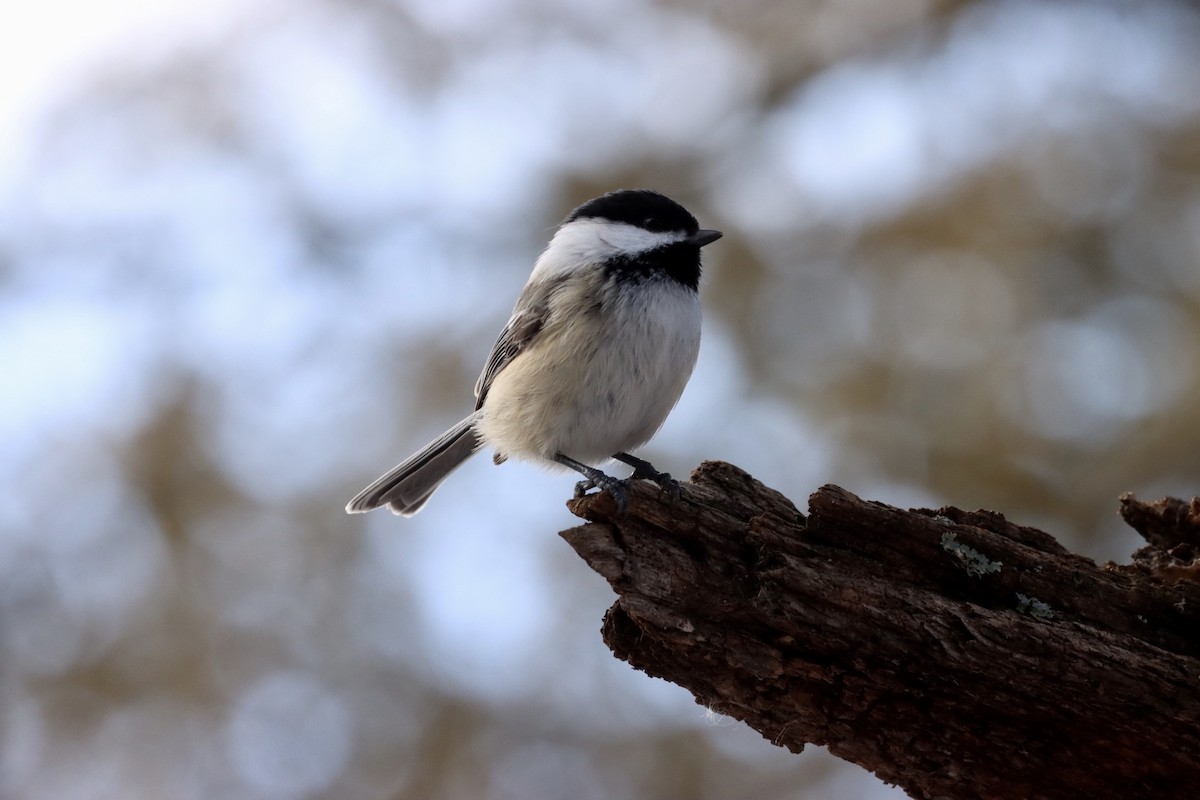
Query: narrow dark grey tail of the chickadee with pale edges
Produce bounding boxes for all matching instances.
[346,411,482,517]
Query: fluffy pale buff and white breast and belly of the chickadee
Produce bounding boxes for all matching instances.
[480,273,701,463]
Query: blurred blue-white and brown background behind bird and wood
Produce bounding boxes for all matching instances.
[0,0,1200,800]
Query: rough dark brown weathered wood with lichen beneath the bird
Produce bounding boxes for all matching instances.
[562,462,1200,799]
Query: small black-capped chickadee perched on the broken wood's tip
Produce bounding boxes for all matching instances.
[346,190,721,516]
